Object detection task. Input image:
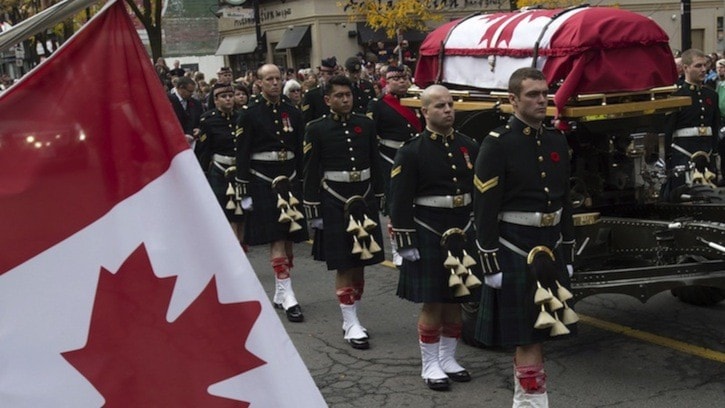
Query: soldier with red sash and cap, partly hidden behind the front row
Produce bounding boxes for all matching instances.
[367,67,423,213]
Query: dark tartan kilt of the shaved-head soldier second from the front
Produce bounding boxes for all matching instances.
[396,206,483,303]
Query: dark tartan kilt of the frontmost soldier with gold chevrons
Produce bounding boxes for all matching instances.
[475,222,576,346]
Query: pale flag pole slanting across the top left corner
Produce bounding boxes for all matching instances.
[0,0,99,52]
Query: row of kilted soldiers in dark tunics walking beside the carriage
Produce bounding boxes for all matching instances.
[197,64,575,406]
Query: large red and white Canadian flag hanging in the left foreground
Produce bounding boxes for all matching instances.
[0,1,326,408]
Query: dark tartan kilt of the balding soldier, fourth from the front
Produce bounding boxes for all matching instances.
[244,176,309,245]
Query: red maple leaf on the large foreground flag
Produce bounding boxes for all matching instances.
[62,245,266,408]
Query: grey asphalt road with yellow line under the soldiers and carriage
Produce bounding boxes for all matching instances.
[248,236,725,408]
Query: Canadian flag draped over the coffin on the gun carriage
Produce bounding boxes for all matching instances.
[415,7,677,114]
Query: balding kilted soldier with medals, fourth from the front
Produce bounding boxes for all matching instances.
[236,64,308,322]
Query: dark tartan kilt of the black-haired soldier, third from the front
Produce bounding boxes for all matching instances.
[312,182,385,270]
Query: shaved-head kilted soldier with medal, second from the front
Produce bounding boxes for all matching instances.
[389,85,481,390]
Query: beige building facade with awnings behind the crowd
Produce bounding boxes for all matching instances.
[216,0,725,75]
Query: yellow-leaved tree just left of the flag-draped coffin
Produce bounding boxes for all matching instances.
[337,0,443,59]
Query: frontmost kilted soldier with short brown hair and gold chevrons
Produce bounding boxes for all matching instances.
[473,68,576,408]
